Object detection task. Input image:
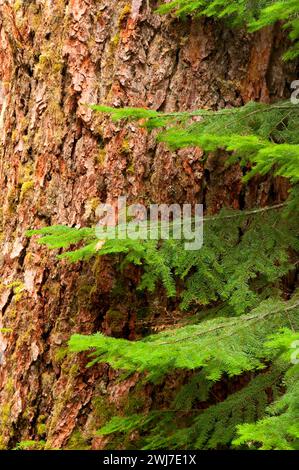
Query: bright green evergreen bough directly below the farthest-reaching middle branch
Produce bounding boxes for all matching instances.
[69,298,299,381]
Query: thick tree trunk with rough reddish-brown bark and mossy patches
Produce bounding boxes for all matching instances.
[0,0,295,448]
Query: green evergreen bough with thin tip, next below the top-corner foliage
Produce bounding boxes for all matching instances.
[93,102,299,183]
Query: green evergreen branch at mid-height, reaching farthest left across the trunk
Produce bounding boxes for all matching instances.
[28,206,299,316]
